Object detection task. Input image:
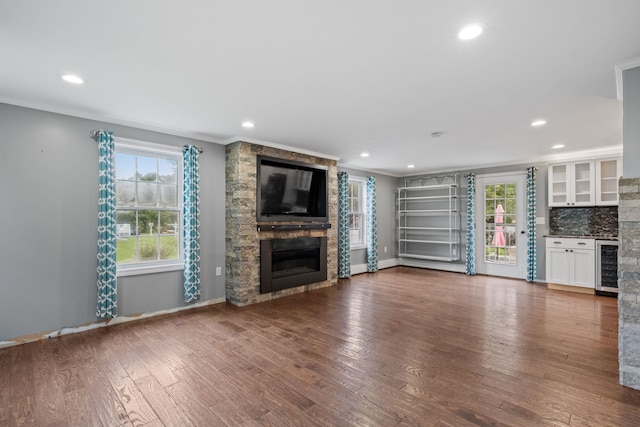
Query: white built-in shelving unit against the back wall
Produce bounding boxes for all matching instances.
[396,174,460,261]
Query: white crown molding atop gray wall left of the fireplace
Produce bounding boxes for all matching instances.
[0,97,223,144]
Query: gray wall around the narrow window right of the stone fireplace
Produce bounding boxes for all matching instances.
[336,165,396,266]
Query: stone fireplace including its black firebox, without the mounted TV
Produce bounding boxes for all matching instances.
[225,141,338,306]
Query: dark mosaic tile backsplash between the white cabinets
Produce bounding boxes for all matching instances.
[549,206,618,237]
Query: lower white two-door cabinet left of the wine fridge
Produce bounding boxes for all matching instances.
[545,237,596,288]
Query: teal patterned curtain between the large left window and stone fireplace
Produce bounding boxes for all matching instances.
[182,145,200,302]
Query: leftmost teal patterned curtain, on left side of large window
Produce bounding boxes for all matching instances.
[95,130,118,318]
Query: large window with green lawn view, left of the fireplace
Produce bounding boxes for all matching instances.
[115,140,182,275]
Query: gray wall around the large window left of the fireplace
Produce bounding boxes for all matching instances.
[0,104,225,341]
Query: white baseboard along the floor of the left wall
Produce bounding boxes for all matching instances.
[0,297,226,348]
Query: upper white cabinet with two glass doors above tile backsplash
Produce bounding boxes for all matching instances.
[549,160,596,207]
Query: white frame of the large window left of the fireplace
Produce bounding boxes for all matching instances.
[115,138,184,277]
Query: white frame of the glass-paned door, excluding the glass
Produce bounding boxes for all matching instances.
[474,172,527,279]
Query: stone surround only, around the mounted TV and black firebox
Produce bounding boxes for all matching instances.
[225,141,338,306]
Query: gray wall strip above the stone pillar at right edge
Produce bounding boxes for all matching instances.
[622,67,640,178]
